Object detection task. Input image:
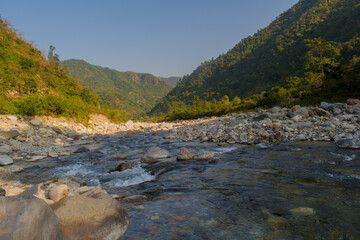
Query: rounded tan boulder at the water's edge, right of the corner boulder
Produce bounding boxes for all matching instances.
[51,195,129,240]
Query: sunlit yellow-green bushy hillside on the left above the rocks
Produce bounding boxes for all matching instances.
[0,18,125,120]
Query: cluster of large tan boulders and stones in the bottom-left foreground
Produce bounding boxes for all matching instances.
[0,167,129,240]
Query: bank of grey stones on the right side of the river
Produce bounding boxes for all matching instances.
[166,99,360,149]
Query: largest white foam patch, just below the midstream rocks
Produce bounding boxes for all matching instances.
[104,166,155,187]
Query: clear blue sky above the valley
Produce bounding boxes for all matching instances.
[0,0,297,77]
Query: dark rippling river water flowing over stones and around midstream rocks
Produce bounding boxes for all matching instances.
[19,132,360,240]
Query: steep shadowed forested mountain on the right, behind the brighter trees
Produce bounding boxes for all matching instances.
[150,0,360,114]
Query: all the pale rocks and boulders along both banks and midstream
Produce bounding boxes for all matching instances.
[0,99,360,239]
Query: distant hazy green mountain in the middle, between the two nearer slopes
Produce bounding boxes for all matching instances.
[62,59,173,118]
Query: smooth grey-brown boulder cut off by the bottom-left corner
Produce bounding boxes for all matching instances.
[0,196,63,240]
